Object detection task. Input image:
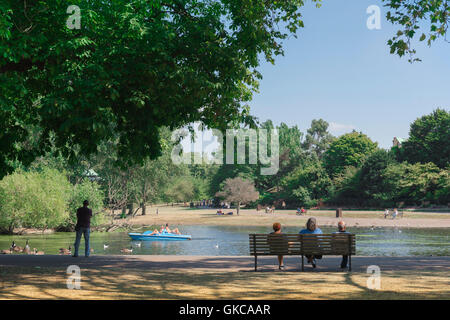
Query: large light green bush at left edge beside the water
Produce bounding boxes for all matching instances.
[0,168,70,233]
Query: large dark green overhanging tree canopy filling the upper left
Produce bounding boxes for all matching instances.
[0,0,317,176]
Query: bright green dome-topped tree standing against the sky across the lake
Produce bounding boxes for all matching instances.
[323,131,377,175]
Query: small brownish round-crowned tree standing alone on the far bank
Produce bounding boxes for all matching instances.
[216,177,259,215]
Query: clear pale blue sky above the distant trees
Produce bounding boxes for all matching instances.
[250,0,450,148]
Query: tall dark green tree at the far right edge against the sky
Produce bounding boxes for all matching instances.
[401,109,450,168]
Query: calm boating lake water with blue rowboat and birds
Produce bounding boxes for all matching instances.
[0,226,450,256]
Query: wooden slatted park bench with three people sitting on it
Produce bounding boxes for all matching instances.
[249,233,356,271]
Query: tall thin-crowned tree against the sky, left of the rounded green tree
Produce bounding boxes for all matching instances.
[303,119,334,158]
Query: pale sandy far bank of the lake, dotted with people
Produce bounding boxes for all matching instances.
[124,207,450,228]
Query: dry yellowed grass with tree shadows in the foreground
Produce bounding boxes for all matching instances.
[0,267,450,300]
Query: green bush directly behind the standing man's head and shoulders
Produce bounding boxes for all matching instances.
[67,179,106,226]
